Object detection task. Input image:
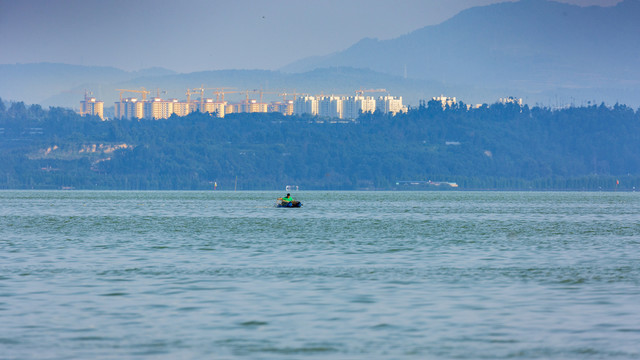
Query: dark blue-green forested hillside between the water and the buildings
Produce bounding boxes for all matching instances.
[0,100,640,190]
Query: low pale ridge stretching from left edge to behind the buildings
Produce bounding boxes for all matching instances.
[0,63,456,108]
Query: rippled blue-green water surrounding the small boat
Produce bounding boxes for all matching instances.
[0,191,640,359]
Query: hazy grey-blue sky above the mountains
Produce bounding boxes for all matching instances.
[0,0,620,72]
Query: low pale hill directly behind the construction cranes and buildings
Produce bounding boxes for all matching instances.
[81,67,444,110]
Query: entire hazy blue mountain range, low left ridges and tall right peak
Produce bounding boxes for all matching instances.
[5,0,640,114]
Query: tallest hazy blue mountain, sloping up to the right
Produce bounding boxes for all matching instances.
[281,0,640,104]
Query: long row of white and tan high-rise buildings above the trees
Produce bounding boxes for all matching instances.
[80,89,407,119]
